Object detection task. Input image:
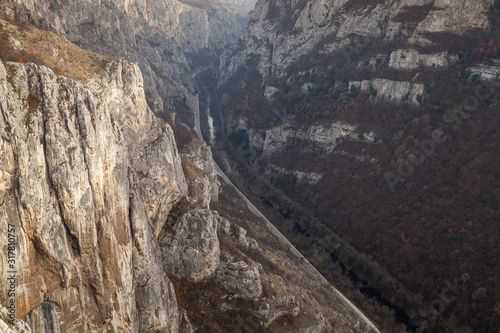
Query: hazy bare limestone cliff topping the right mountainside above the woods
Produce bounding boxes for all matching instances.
[221,0,493,85]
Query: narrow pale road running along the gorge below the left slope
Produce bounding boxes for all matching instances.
[189,79,380,333]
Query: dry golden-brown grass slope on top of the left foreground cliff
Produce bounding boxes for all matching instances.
[0,17,116,81]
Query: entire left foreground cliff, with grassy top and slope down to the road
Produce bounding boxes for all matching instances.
[0,19,380,333]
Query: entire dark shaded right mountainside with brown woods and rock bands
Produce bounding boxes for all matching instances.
[217,0,500,332]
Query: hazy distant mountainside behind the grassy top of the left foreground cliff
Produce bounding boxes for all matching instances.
[0,0,243,120]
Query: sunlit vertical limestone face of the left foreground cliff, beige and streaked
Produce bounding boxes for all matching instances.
[0,35,187,332]
